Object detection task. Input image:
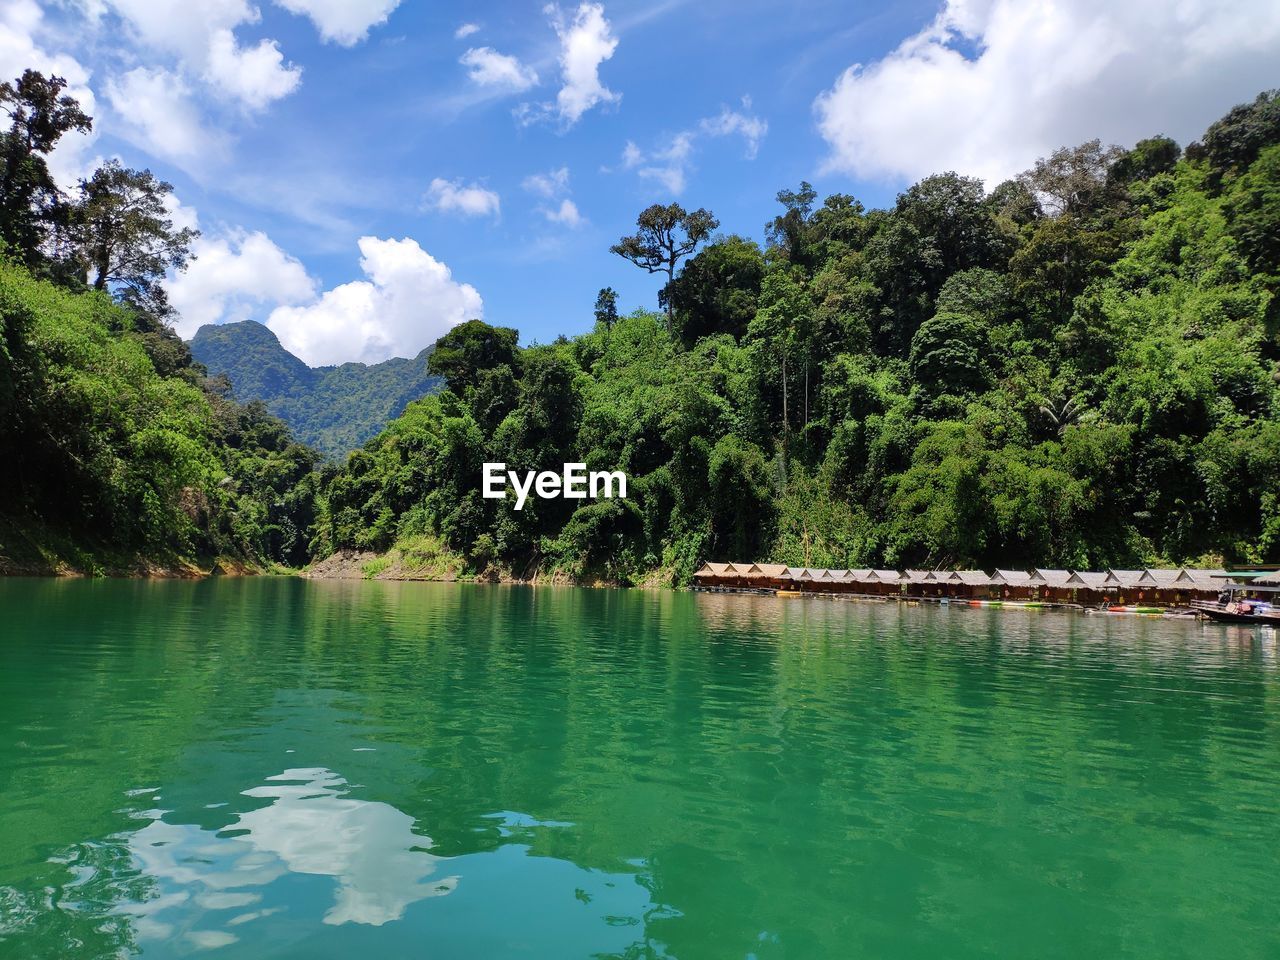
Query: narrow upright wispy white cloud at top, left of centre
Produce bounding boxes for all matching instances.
[516,3,622,128]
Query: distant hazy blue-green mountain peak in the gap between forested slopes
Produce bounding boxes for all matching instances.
[191,320,440,460]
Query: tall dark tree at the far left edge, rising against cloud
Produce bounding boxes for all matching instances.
[0,70,93,266]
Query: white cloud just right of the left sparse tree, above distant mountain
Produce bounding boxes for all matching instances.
[165,229,316,339]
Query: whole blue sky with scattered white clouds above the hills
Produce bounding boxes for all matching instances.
[0,0,1280,365]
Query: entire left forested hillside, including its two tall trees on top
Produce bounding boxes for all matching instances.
[0,70,323,572]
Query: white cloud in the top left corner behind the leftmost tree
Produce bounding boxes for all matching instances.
[0,0,97,188]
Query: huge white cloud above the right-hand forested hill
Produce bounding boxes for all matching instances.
[814,0,1280,186]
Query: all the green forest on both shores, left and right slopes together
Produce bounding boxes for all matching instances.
[0,72,1280,584]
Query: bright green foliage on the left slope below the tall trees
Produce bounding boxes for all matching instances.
[0,265,316,567]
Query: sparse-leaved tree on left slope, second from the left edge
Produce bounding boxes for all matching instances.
[72,160,200,316]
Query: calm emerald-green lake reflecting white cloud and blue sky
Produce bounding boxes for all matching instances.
[0,579,1280,960]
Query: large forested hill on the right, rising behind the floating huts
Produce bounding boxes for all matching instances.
[316,92,1280,581]
